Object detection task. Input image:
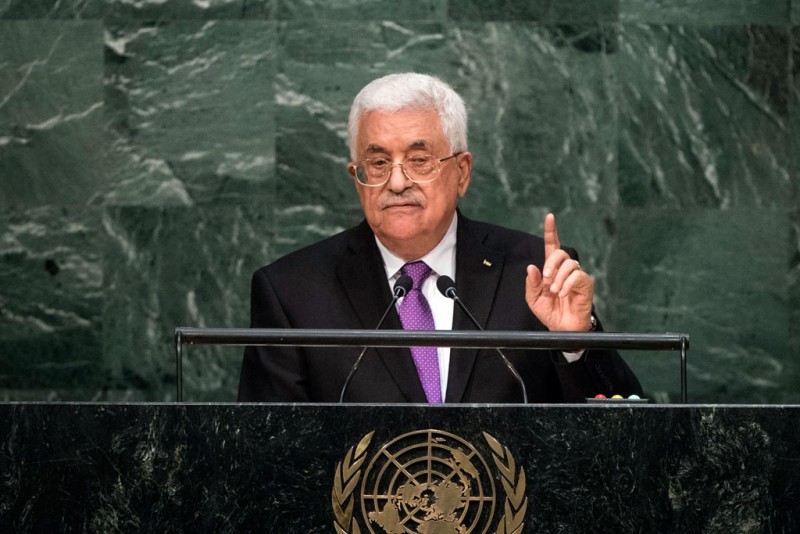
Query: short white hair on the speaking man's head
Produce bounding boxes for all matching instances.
[347,72,467,160]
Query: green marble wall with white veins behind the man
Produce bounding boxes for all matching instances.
[0,0,800,403]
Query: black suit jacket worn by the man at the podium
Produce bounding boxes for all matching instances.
[239,213,641,403]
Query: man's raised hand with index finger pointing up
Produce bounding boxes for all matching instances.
[525,213,594,332]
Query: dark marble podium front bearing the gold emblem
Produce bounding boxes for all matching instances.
[0,403,800,533]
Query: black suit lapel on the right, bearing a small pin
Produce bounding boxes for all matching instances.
[447,212,504,402]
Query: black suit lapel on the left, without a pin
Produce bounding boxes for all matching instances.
[336,221,426,403]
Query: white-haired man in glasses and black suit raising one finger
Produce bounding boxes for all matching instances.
[239,73,641,404]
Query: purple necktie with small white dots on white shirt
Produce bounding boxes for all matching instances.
[400,261,442,404]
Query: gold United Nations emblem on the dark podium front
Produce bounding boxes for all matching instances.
[331,429,528,534]
